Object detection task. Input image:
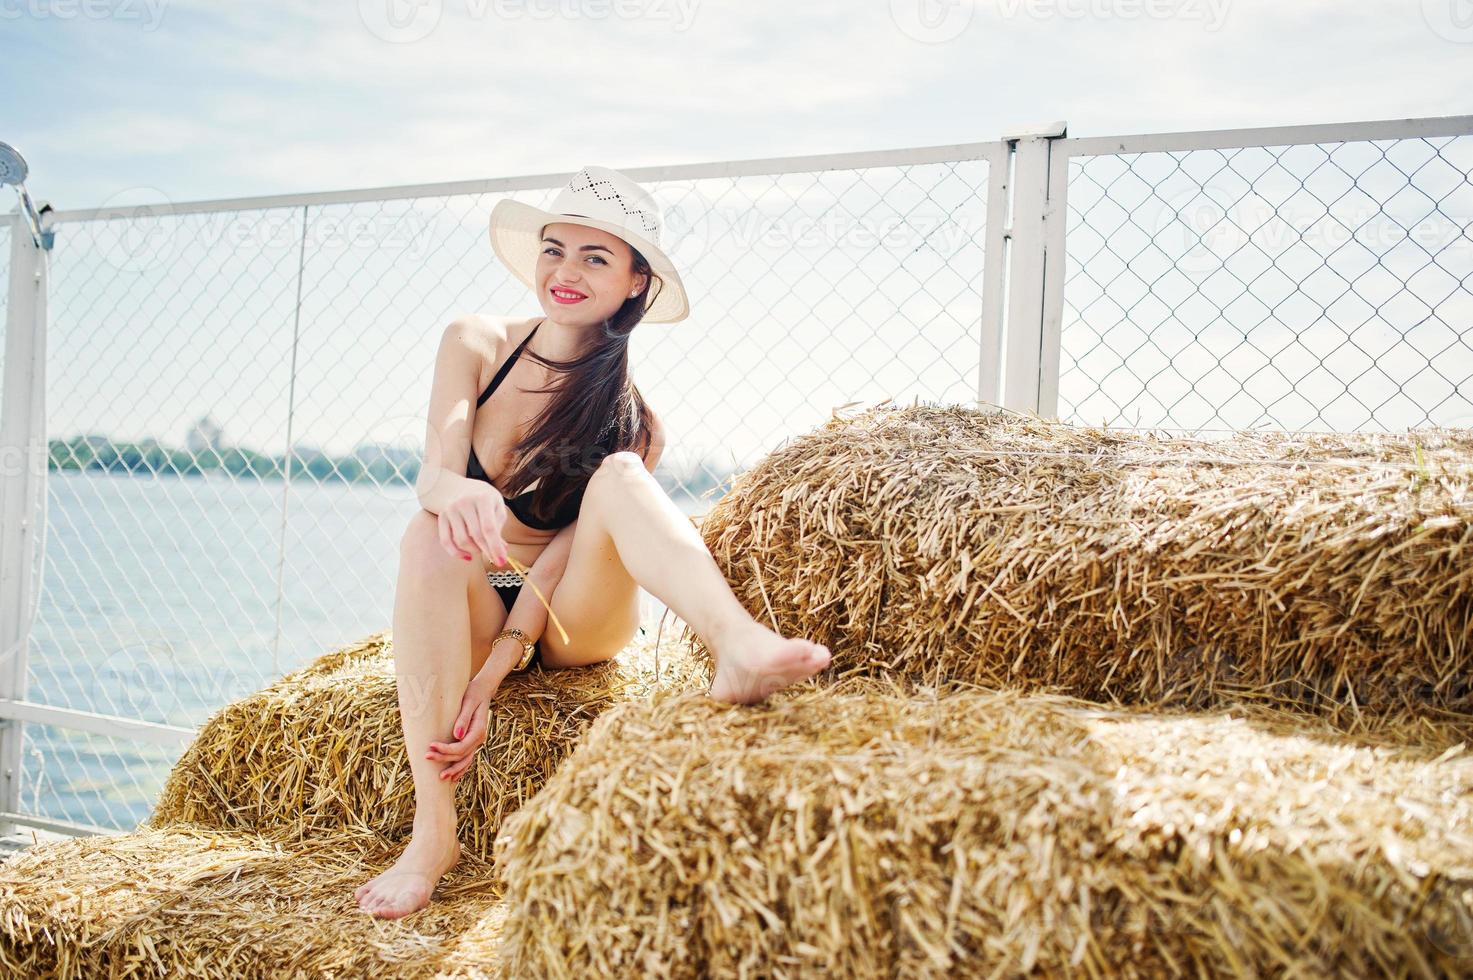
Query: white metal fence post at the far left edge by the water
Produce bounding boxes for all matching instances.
[0,212,47,836]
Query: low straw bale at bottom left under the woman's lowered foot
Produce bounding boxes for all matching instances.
[0,824,505,980]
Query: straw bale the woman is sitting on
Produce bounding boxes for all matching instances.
[143,632,710,858]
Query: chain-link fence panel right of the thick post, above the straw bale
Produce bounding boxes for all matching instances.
[1059,127,1473,432]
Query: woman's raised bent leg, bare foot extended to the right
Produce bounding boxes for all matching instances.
[542,452,829,703]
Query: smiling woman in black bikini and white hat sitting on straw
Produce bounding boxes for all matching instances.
[355,167,829,918]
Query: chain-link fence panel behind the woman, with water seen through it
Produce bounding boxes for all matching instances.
[0,144,1000,828]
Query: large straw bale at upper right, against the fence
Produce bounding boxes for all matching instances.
[683,405,1473,732]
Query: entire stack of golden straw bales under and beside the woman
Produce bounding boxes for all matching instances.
[11,405,1473,979]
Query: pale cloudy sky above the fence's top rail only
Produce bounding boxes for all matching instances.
[0,0,1473,209]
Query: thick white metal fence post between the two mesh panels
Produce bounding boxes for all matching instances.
[1002,122,1068,413]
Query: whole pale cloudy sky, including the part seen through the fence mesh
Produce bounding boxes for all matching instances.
[0,0,1473,461]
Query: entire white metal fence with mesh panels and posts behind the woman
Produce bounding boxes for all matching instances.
[0,116,1473,833]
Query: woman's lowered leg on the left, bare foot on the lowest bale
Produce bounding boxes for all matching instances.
[354,510,505,918]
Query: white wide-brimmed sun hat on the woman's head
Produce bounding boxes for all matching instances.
[491,167,691,323]
